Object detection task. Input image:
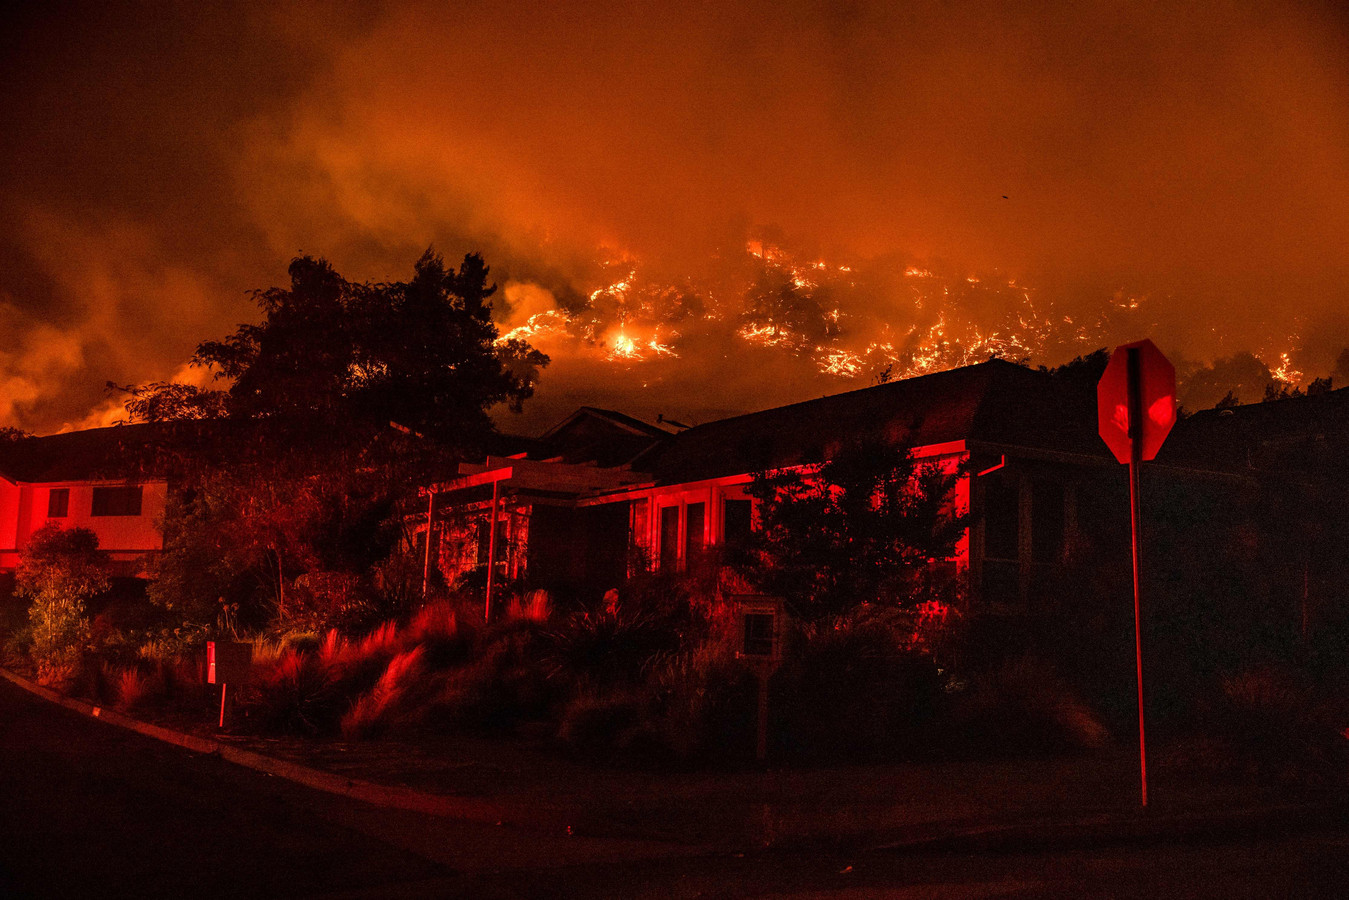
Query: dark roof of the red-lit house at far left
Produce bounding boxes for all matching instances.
[0,424,179,483]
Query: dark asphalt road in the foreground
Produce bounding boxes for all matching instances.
[0,681,1349,900]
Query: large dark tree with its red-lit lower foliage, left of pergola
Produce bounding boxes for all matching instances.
[127,251,548,625]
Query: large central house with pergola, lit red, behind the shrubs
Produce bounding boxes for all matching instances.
[424,360,1128,609]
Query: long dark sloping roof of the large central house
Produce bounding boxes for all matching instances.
[633,359,1106,483]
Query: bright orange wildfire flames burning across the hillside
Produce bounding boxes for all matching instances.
[502,240,1302,396]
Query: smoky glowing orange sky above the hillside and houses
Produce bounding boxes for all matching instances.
[0,1,1349,430]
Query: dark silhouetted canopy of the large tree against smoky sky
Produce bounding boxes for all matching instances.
[127,250,548,450]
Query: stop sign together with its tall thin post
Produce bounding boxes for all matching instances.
[1097,340,1176,807]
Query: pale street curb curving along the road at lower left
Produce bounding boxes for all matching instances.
[0,668,520,827]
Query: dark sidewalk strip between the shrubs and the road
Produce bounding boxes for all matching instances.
[3,672,1349,853]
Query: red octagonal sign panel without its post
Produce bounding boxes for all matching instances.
[1097,340,1176,463]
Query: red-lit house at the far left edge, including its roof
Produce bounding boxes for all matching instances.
[0,425,169,575]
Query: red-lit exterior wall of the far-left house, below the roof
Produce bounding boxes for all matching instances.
[0,480,169,569]
